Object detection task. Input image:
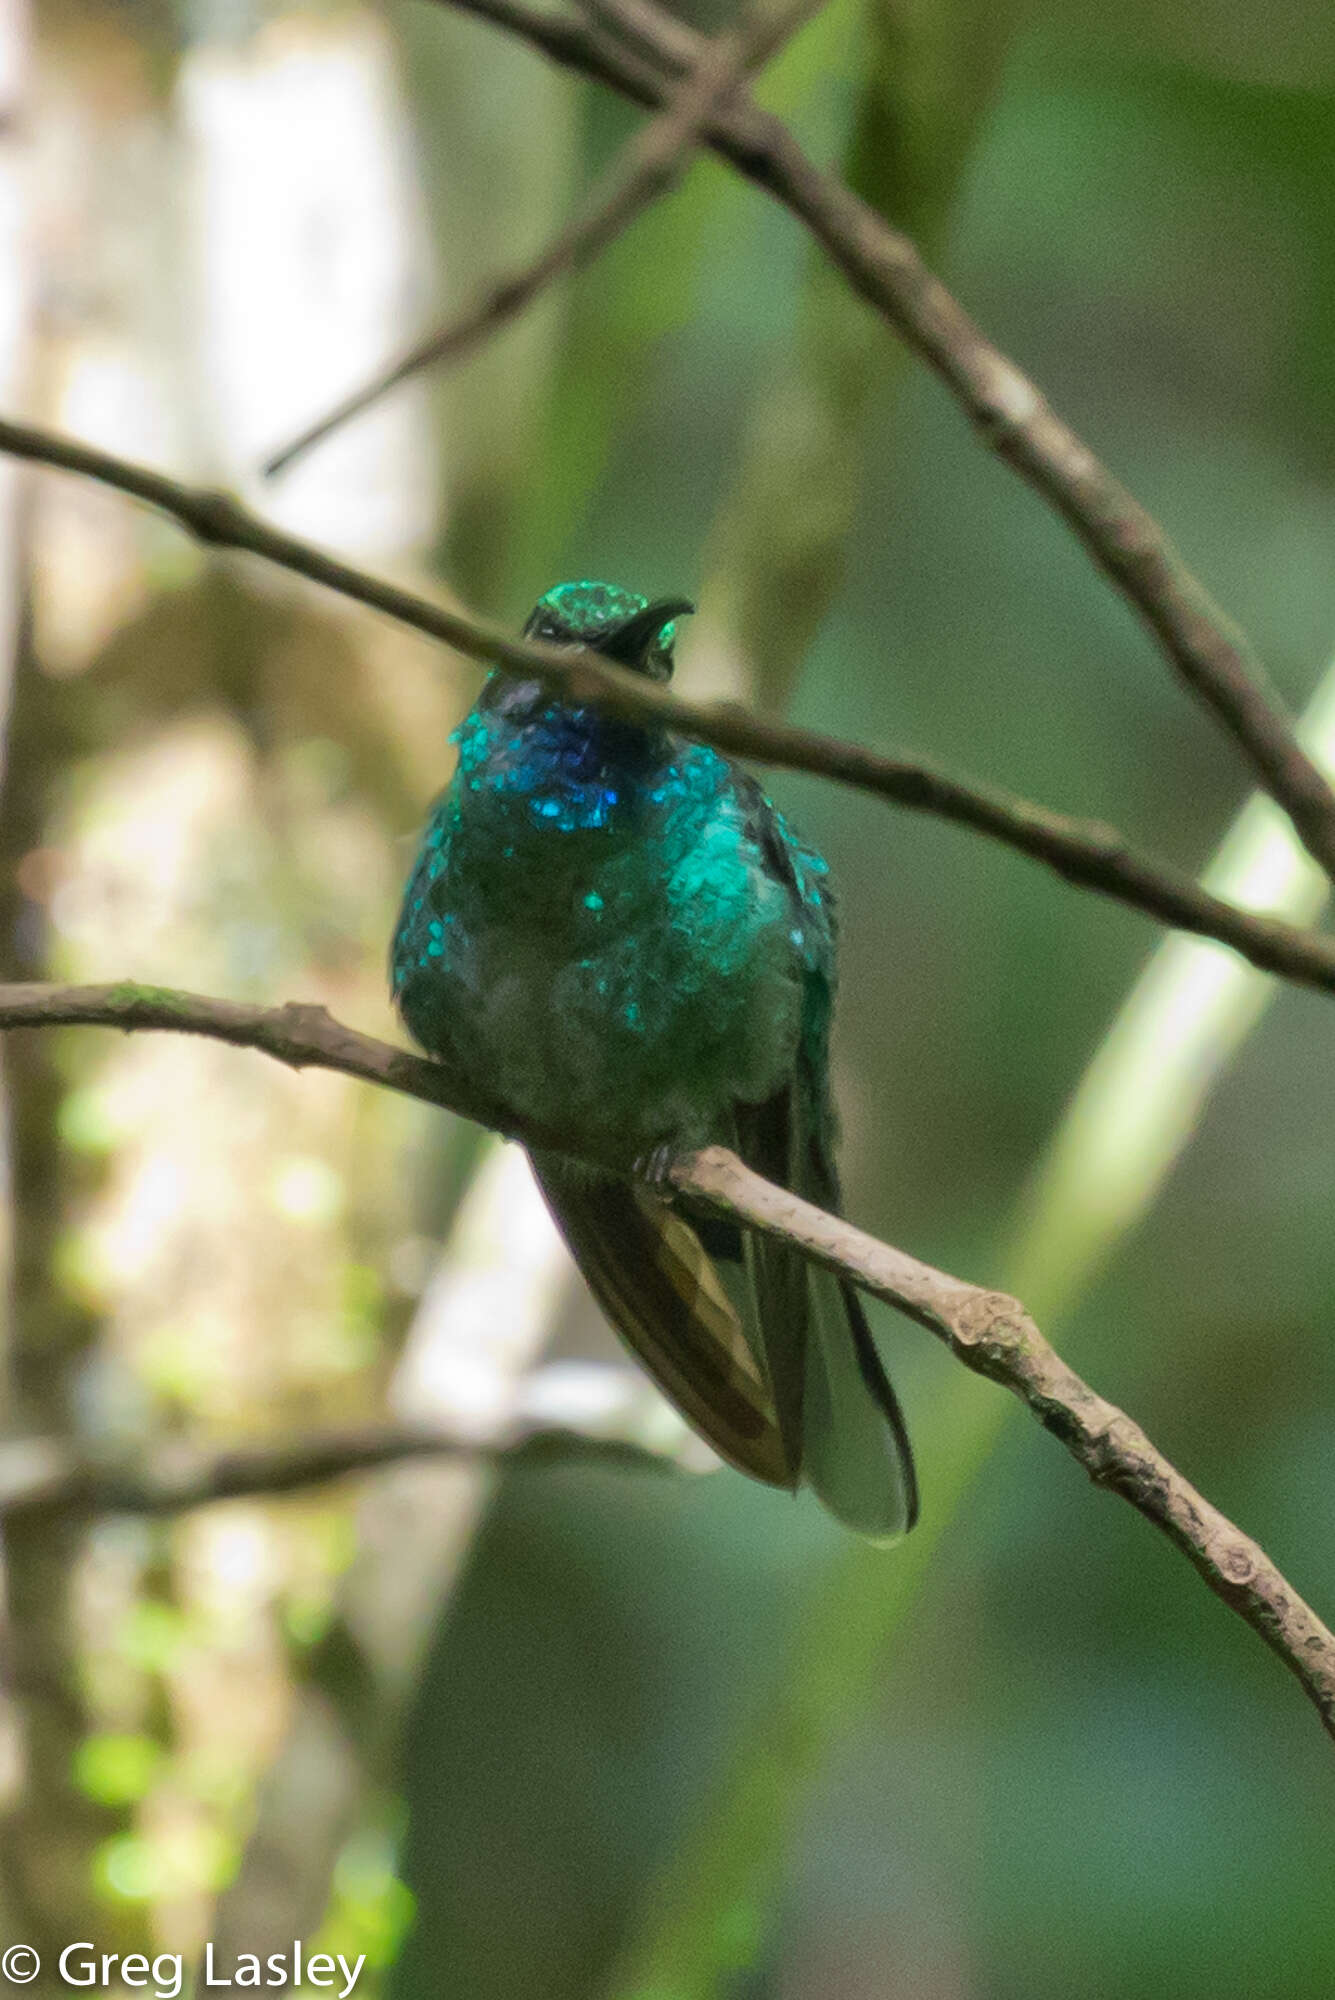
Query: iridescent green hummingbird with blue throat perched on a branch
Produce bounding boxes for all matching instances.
[390,578,917,1540]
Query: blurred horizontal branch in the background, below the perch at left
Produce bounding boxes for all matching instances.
[0,1424,669,1522]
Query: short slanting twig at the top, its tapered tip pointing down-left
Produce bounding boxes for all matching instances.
[262,0,821,478]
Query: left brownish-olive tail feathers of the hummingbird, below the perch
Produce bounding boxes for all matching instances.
[530,1152,797,1488]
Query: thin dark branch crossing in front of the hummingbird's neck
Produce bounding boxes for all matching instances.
[0,420,1335,992]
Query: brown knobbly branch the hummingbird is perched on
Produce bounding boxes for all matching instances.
[0,984,1335,1736]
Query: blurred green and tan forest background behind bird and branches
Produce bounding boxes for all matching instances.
[0,0,1335,2000]
